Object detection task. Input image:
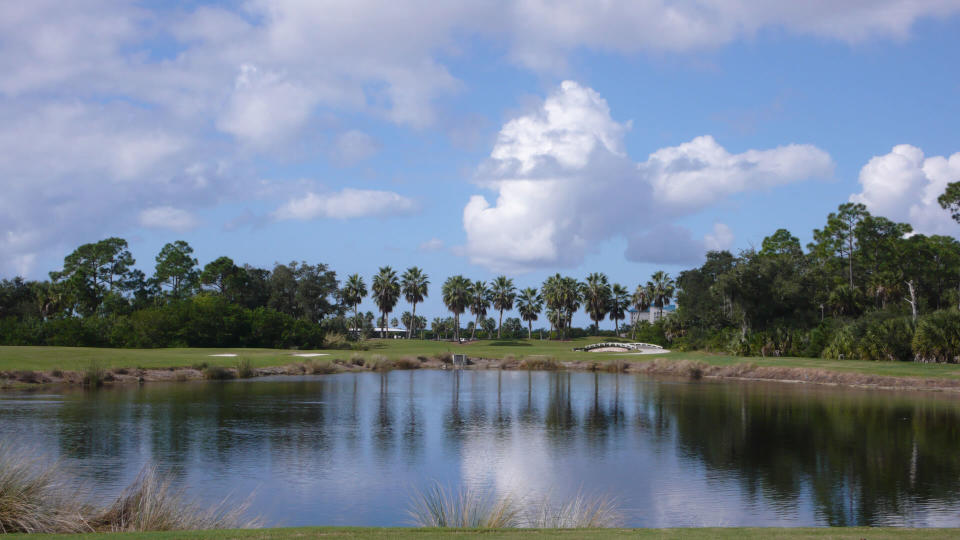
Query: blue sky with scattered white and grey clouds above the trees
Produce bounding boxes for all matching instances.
[0,0,960,326]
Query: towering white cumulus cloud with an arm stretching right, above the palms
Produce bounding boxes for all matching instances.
[463,81,833,271]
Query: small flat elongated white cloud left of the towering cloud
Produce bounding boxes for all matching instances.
[274,188,418,220]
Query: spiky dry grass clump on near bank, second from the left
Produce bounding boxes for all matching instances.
[93,466,259,532]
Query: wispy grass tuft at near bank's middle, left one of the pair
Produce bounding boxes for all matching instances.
[407,483,520,529]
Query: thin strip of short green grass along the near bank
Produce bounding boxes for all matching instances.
[9,527,960,540]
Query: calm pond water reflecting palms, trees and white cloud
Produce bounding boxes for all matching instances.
[0,371,960,527]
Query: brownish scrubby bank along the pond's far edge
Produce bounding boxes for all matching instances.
[0,355,960,392]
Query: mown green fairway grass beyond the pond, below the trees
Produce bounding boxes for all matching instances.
[0,338,960,379]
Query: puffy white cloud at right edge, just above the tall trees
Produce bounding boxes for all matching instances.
[850,144,960,235]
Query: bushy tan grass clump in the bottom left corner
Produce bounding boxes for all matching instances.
[0,442,92,533]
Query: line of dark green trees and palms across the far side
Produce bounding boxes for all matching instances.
[0,188,960,361]
